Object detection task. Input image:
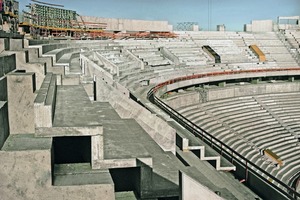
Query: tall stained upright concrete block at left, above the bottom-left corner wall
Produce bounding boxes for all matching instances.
[7,72,35,134]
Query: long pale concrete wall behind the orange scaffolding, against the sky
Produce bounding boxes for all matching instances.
[78,16,172,31]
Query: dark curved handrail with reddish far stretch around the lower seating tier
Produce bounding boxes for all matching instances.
[147,67,300,199]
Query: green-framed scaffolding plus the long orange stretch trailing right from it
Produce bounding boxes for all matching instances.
[18,0,177,39]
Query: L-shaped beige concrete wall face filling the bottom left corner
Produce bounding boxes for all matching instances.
[0,150,115,200]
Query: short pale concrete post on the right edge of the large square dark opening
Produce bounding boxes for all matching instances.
[91,135,104,169]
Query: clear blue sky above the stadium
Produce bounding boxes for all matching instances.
[19,0,300,30]
